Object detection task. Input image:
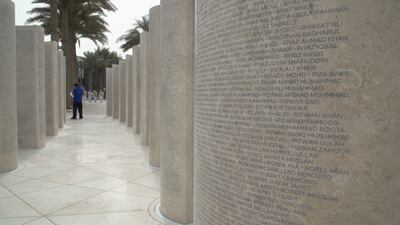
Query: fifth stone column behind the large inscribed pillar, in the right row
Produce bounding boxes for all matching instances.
[125,55,133,127]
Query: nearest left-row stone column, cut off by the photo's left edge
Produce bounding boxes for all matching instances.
[0,0,18,173]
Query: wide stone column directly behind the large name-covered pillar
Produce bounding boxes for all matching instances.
[160,0,194,224]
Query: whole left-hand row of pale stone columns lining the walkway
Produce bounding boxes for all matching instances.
[0,0,66,173]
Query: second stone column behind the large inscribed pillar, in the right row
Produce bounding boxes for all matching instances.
[148,6,161,167]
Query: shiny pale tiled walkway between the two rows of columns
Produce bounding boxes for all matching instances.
[0,103,160,225]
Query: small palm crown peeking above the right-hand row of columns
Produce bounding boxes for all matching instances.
[117,16,149,52]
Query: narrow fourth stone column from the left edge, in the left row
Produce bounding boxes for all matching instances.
[58,51,66,128]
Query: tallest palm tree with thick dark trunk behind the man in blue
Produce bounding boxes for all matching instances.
[27,0,116,108]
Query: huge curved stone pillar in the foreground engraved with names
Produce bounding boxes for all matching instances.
[194,0,400,225]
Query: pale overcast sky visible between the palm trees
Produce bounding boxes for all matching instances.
[13,0,160,56]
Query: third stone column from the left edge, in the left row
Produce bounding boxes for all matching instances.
[44,41,59,136]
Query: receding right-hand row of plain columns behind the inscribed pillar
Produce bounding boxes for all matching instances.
[106,0,194,224]
